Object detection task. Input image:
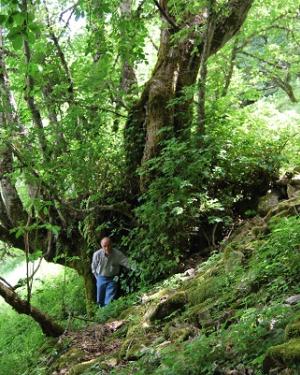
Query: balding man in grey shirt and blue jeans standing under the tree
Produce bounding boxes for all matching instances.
[91,237,131,307]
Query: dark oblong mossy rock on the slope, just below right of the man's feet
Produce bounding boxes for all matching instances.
[145,292,187,321]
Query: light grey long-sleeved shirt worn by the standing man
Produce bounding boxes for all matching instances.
[91,249,131,276]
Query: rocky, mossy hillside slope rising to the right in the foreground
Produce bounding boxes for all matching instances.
[32,197,300,375]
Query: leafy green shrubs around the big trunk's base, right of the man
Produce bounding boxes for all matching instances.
[127,104,286,283]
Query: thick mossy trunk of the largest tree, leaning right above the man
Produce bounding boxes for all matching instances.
[125,0,253,191]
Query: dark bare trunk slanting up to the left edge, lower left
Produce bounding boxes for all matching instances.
[0,281,64,337]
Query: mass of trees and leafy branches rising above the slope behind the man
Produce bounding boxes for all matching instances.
[0,0,299,328]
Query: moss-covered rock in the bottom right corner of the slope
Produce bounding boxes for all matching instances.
[263,338,300,373]
